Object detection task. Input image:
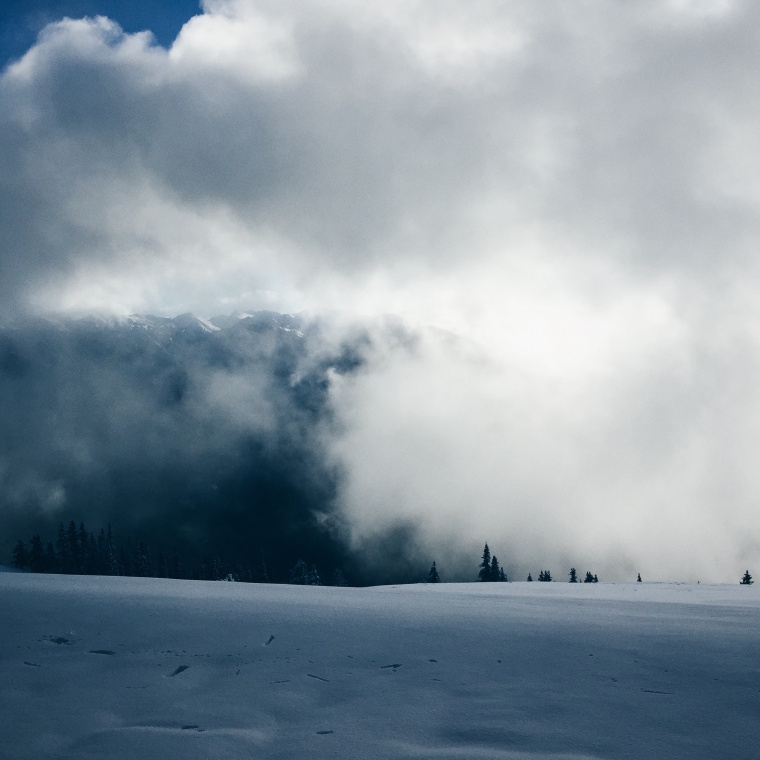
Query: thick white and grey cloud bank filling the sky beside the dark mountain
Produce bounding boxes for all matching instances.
[0,0,760,580]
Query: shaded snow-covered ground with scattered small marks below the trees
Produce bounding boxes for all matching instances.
[0,573,760,760]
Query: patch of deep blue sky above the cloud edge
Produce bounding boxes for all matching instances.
[0,0,200,63]
